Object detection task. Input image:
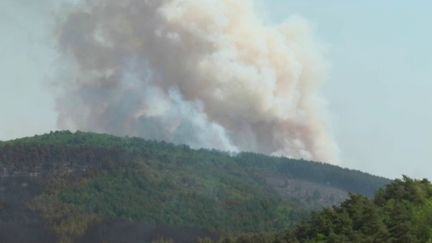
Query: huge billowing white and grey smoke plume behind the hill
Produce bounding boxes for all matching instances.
[57,0,337,162]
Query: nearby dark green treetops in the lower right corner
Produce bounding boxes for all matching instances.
[215,177,432,243]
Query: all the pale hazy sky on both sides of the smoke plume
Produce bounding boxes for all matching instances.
[0,0,432,178]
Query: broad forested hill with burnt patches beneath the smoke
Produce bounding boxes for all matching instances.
[0,131,390,242]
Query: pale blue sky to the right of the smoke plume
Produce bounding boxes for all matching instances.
[266,0,432,178]
